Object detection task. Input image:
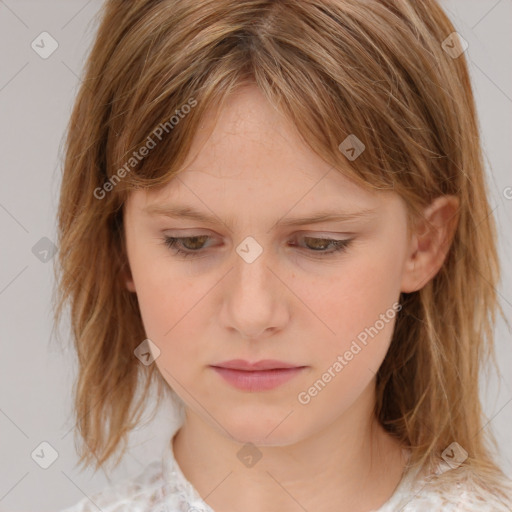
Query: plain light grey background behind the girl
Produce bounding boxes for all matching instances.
[0,0,512,512]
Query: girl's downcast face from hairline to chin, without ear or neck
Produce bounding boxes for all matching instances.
[125,87,416,445]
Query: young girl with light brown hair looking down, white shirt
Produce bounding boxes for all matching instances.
[56,0,512,512]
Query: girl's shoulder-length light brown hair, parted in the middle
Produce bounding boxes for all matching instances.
[55,0,506,498]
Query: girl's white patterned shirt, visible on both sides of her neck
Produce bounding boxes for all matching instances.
[62,428,512,512]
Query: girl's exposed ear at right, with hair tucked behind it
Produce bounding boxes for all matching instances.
[401,195,459,293]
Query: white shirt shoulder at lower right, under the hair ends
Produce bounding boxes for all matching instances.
[388,466,512,512]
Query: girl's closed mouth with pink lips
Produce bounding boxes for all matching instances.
[211,359,307,392]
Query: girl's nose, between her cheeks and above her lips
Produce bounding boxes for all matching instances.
[221,243,290,340]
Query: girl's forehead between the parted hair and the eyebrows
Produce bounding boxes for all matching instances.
[126,86,402,222]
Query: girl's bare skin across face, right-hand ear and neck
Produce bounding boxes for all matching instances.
[124,87,457,512]
